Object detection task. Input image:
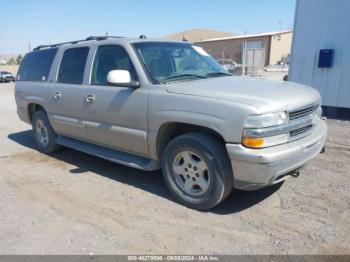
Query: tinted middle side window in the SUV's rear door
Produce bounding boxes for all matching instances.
[57,47,89,84]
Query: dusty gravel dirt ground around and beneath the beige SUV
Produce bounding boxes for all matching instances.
[0,84,350,254]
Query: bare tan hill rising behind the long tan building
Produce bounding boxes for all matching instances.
[162,29,236,42]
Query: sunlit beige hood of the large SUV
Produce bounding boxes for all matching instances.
[166,77,320,113]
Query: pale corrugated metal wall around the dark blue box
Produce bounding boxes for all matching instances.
[289,0,350,108]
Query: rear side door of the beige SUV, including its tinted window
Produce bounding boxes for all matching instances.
[50,47,89,139]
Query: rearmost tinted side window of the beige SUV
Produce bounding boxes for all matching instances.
[17,48,57,81]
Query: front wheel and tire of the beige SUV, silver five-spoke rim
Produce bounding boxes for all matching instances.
[162,133,233,210]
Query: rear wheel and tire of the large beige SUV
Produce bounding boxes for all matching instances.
[32,111,61,154]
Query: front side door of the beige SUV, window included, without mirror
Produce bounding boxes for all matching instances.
[84,45,148,158]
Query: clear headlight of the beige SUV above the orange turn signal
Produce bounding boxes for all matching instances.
[244,112,288,128]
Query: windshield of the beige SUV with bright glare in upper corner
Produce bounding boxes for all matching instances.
[134,42,230,83]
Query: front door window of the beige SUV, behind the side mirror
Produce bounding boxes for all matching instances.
[91,45,137,85]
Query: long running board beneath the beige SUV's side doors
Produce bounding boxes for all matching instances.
[56,136,160,171]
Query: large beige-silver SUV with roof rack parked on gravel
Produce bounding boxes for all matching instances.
[15,37,327,210]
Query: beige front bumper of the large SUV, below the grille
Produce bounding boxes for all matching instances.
[226,120,327,190]
